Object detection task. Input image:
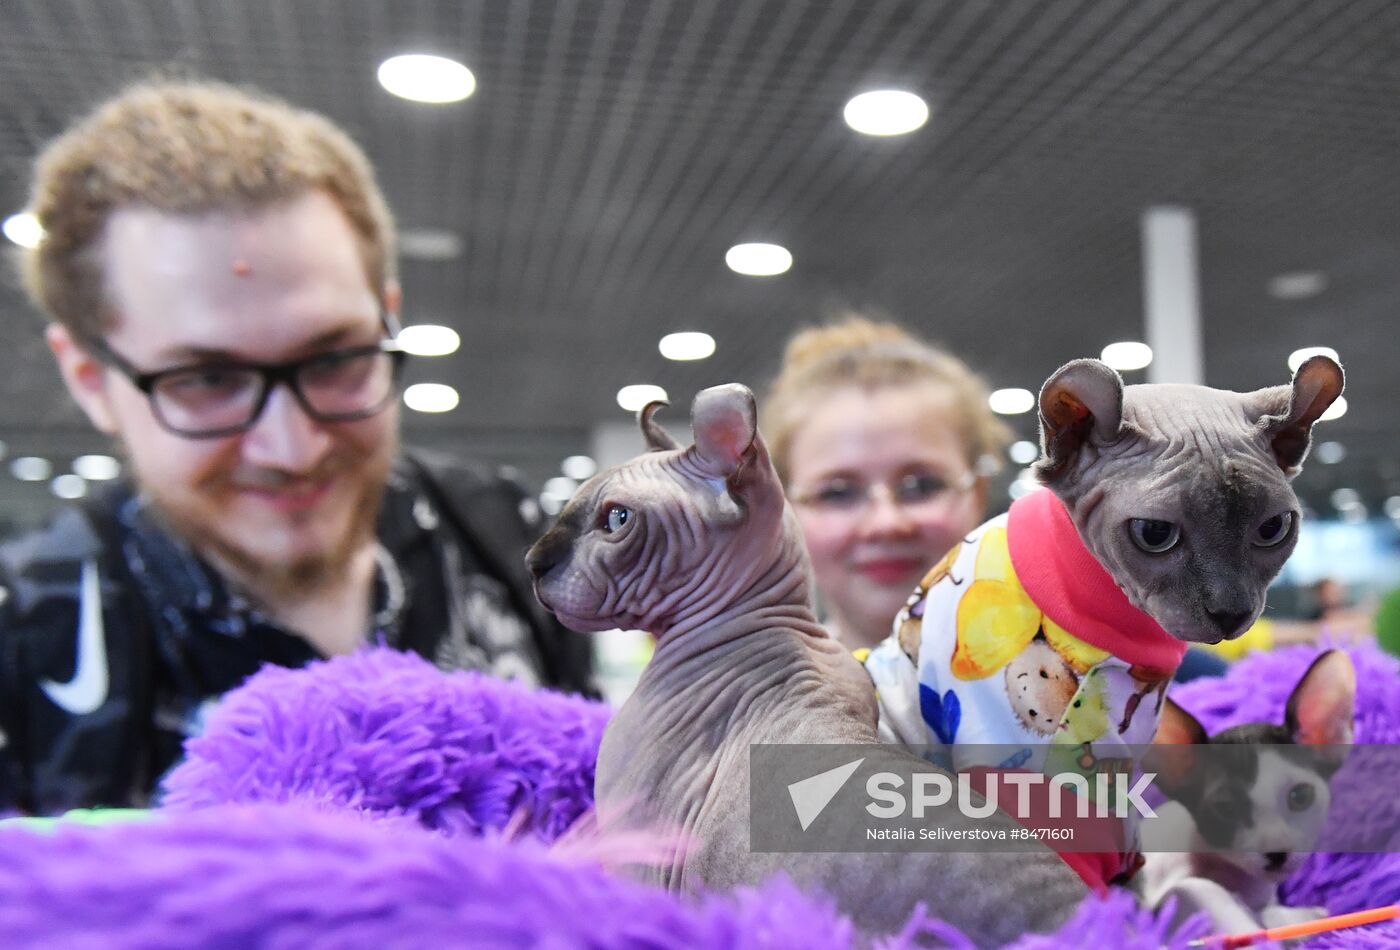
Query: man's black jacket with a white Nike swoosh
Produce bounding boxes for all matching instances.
[0,452,595,814]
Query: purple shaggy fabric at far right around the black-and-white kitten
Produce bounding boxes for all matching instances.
[1172,645,1400,950]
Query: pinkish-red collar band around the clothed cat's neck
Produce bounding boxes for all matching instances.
[1007,488,1186,673]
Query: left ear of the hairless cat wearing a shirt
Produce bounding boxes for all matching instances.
[1036,360,1123,483]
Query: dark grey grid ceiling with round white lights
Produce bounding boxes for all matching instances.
[0,0,1400,520]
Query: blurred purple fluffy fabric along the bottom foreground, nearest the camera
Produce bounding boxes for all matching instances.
[0,804,851,950]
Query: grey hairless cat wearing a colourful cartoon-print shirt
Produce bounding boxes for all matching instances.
[865,357,1344,766]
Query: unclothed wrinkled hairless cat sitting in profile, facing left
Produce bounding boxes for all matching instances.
[528,385,1085,946]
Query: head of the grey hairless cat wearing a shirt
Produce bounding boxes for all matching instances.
[1036,357,1343,644]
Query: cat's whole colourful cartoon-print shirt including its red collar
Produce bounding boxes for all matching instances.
[858,490,1186,883]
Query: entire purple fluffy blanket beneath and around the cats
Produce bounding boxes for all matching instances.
[0,648,1400,950]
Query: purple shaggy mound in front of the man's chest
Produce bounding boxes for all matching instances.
[162,649,609,841]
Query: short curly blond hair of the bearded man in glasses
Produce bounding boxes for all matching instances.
[21,80,396,336]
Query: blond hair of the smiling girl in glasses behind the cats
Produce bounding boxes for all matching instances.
[762,316,1011,484]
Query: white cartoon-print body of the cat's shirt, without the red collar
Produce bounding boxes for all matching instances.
[860,515,1168,767]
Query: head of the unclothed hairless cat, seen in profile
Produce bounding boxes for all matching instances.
[525,385,806,637]
